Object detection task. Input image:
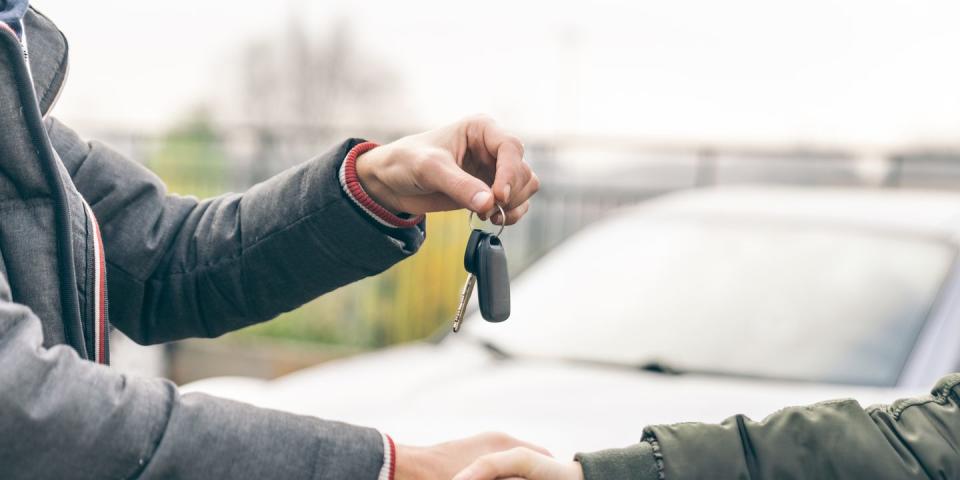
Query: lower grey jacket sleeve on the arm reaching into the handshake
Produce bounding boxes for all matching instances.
[0,272,383,480]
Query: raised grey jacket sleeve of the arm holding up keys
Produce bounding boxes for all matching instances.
[47,119,423,343]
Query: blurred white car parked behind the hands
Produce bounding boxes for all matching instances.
[185,188,960,456]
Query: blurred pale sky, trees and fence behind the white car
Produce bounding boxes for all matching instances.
[33,0,960,390]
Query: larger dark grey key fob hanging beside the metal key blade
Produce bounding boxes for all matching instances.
[473,234,510,322]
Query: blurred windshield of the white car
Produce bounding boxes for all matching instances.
[467,212,955,386]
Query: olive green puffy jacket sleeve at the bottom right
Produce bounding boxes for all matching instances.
[579,373,960,480]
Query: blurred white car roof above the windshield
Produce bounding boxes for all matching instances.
[640,186,960,243]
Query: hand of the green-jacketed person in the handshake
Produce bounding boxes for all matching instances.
[453,447,583,480]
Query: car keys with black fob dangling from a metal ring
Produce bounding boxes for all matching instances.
[453,204,510,333]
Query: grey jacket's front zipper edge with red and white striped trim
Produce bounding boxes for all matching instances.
[0,24,90,359]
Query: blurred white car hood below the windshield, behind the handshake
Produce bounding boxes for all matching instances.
[182,337,925,457]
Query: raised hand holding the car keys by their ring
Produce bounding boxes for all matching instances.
[357,116,540,225]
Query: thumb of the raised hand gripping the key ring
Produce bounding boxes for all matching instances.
[417,151,494,213]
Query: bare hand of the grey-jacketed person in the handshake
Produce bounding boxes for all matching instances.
[395,433,550,480]
